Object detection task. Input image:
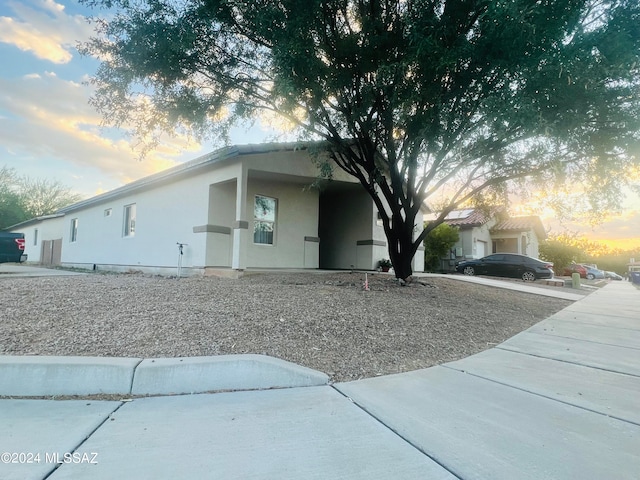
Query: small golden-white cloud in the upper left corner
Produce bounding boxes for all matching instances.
[0,0,93,64]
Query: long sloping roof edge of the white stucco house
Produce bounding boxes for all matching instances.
[58,142,318,214]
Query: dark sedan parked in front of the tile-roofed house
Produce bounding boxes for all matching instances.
[456,253,554,282]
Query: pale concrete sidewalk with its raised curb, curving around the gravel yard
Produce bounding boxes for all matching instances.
[0,282,640,480]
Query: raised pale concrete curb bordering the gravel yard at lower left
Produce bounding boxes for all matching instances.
[0,354,329,397]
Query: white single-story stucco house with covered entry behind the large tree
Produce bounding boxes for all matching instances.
[11,143,424,274]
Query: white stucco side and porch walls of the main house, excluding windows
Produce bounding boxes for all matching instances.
[52,152,332,273]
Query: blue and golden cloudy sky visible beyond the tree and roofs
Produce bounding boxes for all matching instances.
[0,0,640,253]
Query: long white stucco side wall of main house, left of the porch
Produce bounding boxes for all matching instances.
[62,177,209,274]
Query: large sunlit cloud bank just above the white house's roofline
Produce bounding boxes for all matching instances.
[0,72,200,190]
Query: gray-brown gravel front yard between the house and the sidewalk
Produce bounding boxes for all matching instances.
[0,273,571,381]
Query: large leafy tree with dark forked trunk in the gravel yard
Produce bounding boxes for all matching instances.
[83,0,640,279]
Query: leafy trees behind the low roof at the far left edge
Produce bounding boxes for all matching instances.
[0,166,82,229]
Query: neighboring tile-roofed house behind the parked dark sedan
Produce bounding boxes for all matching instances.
[428,208,547,270]
